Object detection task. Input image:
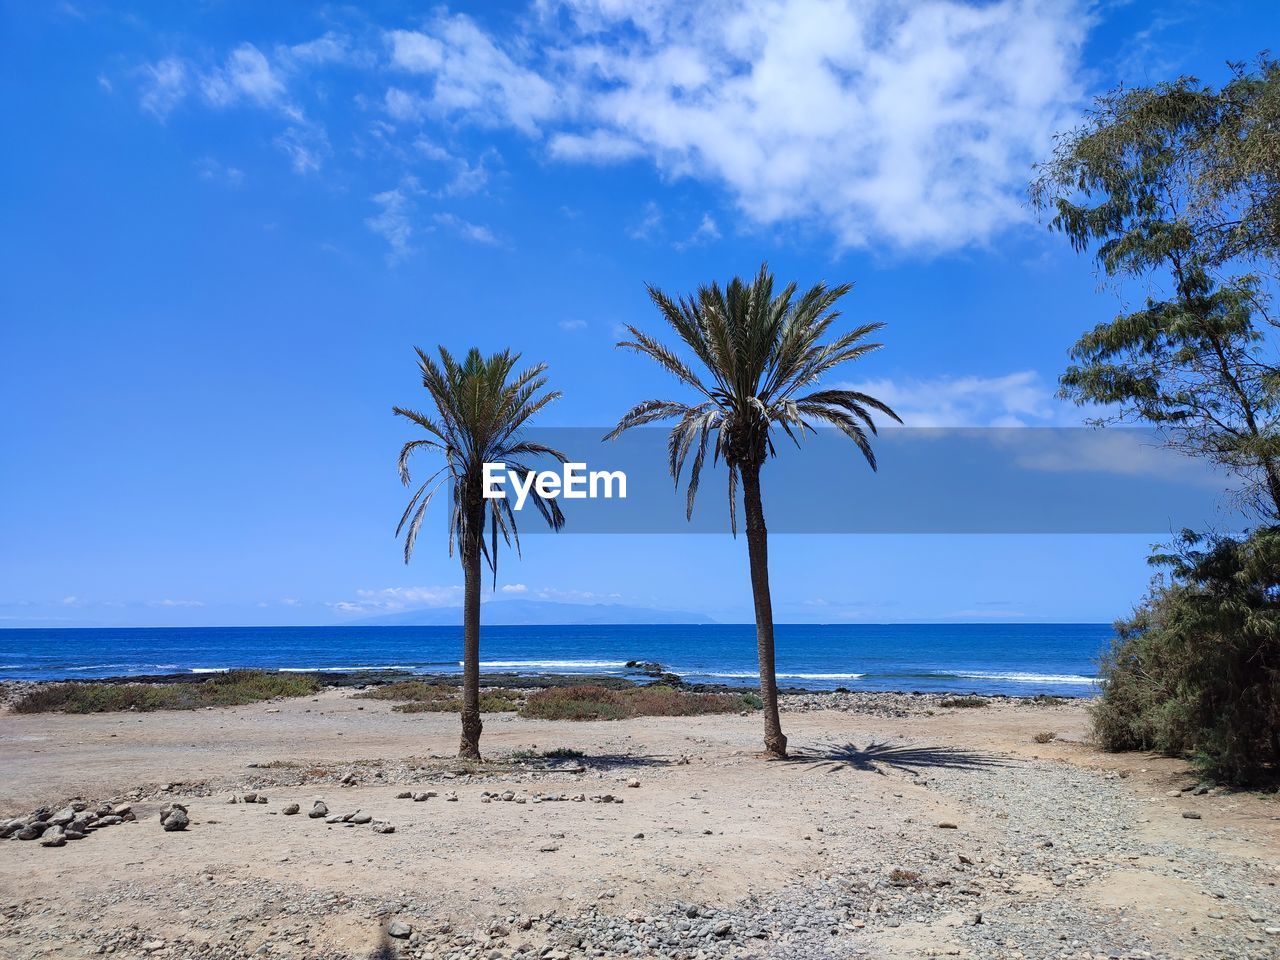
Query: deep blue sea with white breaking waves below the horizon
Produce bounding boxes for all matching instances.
[0,623,1112,696]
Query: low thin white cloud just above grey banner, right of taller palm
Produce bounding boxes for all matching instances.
[840,370,1064,428]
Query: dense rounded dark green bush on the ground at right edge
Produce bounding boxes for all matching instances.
[1092,527,1280,783]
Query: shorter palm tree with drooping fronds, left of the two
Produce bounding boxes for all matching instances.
[392,347,564,760]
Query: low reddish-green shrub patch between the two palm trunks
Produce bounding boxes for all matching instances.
[520,684,760,721]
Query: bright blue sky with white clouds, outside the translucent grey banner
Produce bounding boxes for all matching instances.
[0,0,1280,626]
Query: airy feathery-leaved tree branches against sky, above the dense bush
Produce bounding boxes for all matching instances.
[1032,59,1280,516]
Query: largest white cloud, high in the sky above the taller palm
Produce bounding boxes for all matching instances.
[388,0,1091,250]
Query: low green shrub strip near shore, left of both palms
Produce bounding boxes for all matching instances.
[13,669,320,713]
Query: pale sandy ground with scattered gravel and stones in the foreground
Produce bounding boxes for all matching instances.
[0,690,1280,960]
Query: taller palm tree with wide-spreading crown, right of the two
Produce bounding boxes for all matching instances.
[607,264,902,756]
